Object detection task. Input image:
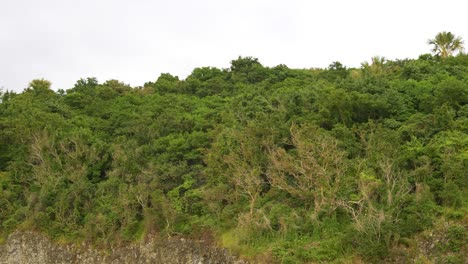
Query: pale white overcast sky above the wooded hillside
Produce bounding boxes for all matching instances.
[0,0,468,91]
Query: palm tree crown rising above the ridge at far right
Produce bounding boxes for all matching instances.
[427,31,464,58]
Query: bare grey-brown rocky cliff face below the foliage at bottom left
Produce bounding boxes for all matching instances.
[0,232,246,264]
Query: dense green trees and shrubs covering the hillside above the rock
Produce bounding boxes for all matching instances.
[0,54,468,263]
